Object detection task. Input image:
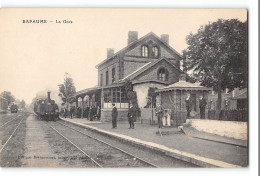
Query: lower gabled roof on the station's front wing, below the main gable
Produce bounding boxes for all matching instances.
[119,57,182,82]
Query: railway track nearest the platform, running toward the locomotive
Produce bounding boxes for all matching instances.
[47,122,159,168]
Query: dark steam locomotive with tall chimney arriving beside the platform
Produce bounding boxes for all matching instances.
[34,92,59,121]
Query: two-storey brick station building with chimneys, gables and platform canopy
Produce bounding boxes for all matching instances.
[70,31,183,121]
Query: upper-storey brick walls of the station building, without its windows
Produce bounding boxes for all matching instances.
[97,31,180,86]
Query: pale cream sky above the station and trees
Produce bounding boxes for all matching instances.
[0,8,247,103]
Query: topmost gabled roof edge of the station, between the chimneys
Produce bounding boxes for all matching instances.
[96,32,182,68]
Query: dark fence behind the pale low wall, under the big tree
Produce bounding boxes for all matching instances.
[208,109,248,122]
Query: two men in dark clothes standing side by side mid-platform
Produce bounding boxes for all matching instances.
[112,103,137,129]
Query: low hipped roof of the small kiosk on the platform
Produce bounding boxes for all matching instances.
[156,81,212,92]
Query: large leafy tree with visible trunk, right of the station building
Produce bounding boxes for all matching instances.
[183,19,248,117]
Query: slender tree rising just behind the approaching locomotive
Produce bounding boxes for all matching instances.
[58,73,76,105]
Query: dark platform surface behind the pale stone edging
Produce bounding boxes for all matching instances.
[61,118,248,167]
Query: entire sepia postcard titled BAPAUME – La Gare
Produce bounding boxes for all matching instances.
[0,8,251,168]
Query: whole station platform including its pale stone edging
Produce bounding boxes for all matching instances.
[61,118,248,168]
